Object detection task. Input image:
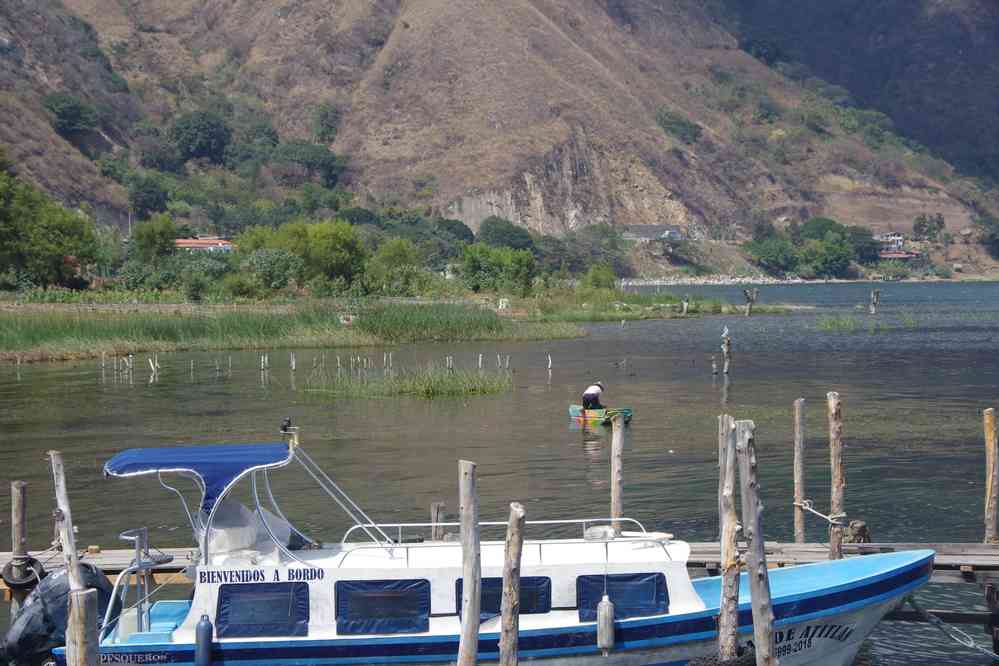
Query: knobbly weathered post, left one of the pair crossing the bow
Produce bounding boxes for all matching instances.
[718,414,739,661]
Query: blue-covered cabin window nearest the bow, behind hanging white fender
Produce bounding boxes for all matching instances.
[576,573,669,622]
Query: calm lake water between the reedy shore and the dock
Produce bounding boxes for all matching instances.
[0,283,999,666]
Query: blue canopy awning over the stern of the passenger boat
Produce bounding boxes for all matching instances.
[104,442,291,512]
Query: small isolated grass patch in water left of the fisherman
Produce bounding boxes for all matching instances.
[306,367,513,399]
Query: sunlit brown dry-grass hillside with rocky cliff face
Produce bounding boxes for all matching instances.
[0,0,996,239]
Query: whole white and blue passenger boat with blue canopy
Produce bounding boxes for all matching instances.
[55,433,934,666]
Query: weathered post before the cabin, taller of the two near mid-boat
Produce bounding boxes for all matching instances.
[458,460,482,666]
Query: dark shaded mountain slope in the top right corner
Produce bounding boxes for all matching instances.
[729,0,999,178]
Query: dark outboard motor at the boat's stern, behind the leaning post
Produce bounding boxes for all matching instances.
[0,562,114,666]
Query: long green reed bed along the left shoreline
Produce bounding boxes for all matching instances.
[0,302,584,362]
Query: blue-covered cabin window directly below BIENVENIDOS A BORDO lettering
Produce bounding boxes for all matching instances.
[215,583,309,638]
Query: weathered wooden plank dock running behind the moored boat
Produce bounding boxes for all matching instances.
[0,541,999,589]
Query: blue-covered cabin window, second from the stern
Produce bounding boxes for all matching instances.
[334,579,430,634]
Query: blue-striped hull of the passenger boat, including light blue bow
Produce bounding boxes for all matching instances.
[64,551,933,666]
